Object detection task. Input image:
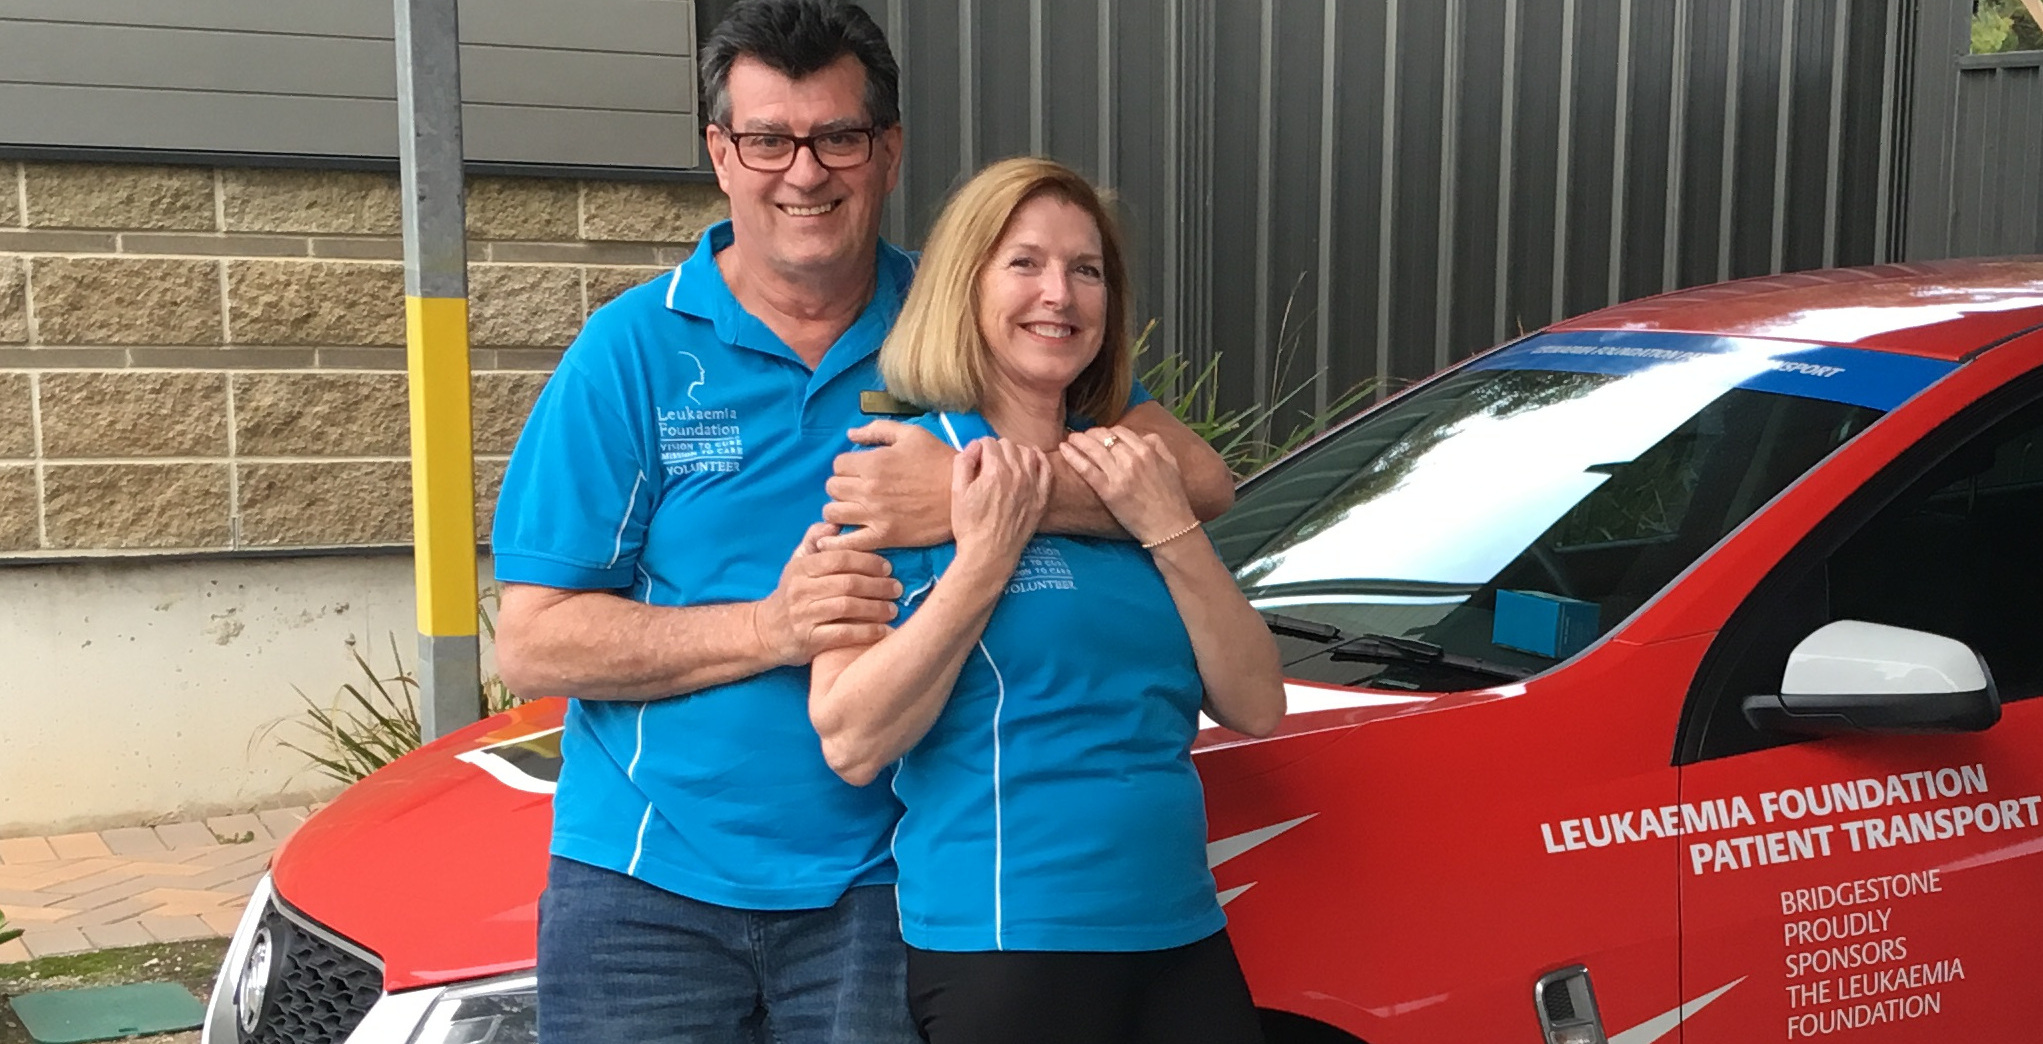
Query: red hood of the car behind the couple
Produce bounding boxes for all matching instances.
[272,684,1438,991]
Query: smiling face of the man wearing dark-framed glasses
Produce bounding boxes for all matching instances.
[709,55,901,276]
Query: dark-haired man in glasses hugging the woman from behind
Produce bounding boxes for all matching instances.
[494,0,1232,1044]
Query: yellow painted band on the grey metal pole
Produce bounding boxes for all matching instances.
[405,296,476,637]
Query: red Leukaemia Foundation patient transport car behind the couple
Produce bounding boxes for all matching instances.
[206,259,2043,1044]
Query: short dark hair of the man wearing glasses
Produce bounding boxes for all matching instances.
[701,0,901,127]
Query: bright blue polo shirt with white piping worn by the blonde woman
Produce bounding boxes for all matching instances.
[885,413,1226,952]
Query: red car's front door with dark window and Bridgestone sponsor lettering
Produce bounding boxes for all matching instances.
[1677,353,2043,1044]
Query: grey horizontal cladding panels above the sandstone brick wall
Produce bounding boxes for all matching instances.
[0,0,701,176]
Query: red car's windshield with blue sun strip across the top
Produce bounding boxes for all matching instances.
[1211,333,1953,691]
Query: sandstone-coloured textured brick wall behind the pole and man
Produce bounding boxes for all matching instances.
[0,163,725,556]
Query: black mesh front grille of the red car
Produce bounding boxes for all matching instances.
[241,905,382,1044]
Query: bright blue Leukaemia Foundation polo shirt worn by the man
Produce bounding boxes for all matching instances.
[494,223,913,909]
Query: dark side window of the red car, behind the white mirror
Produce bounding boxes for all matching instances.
[1683,375,2043,758]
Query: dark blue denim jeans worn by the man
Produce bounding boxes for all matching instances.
[539,856,919,1044]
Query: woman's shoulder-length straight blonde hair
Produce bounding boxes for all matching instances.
[881,157,1134,425]
